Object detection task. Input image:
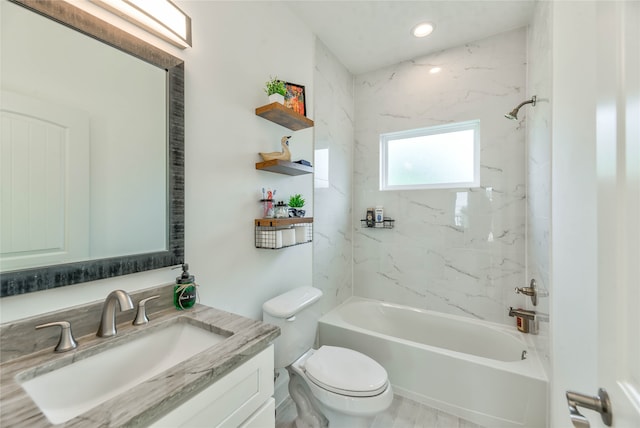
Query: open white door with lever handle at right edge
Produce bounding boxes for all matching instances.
[596,1,640,427]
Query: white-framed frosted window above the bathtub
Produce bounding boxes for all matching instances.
[380,120,480,190]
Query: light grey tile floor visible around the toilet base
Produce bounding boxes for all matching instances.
[276,395,482,428]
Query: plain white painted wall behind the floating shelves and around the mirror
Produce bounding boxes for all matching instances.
[0,1,315,322]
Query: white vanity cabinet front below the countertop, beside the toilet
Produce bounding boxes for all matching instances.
[151,345,275,428]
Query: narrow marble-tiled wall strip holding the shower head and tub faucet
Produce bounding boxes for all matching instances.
[526,2,552,374]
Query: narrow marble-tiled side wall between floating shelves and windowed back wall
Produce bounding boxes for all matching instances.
[313,40,354,313]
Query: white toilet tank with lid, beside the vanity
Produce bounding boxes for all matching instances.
[262,287,322,368]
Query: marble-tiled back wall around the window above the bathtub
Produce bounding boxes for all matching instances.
[352,28,527,324]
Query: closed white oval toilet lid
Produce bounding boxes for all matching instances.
[304,346,387,397]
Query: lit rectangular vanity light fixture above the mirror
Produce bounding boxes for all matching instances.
[91,0,191,49]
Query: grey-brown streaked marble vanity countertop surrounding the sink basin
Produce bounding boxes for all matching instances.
[0,304,280,428]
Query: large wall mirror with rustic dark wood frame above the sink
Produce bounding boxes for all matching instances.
[0,0,184,297]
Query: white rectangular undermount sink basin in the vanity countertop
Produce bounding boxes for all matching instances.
[20,322,226,424]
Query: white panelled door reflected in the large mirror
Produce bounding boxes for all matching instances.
[0,90,90,272]
